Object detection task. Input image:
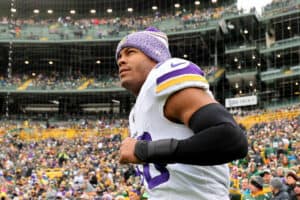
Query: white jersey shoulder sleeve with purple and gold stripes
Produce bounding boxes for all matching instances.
[155,58,211,96]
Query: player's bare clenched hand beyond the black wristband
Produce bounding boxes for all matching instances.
[119,137,142,164]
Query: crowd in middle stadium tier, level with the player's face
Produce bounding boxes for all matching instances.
[0,66,218,90]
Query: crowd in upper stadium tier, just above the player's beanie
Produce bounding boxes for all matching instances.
[0,4,239,40]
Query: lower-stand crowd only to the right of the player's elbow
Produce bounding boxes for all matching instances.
[227,105,300,200]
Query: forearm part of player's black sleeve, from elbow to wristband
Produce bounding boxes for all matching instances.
[174,123,248,165]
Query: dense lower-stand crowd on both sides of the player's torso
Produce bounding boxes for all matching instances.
[0,106,300,200]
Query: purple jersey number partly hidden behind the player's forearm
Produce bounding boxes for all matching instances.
[138,132,170,189]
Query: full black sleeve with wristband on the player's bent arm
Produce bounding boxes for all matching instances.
[135,103,248,165]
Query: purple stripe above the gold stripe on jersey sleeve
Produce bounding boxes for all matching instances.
[156,63,204,85]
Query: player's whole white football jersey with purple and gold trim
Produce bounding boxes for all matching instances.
[129,58,229,200]
